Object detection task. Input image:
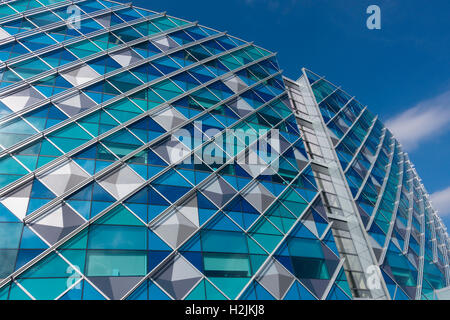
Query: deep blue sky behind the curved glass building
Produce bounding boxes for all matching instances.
[124,0,450,228]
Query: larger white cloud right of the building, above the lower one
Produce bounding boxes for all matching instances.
[386,90,450,151]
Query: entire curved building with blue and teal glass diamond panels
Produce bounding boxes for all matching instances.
[0,0,450,300]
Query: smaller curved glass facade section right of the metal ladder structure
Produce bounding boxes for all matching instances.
[306,71,449,299]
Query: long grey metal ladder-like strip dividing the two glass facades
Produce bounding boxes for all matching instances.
[284,69,390,300]
